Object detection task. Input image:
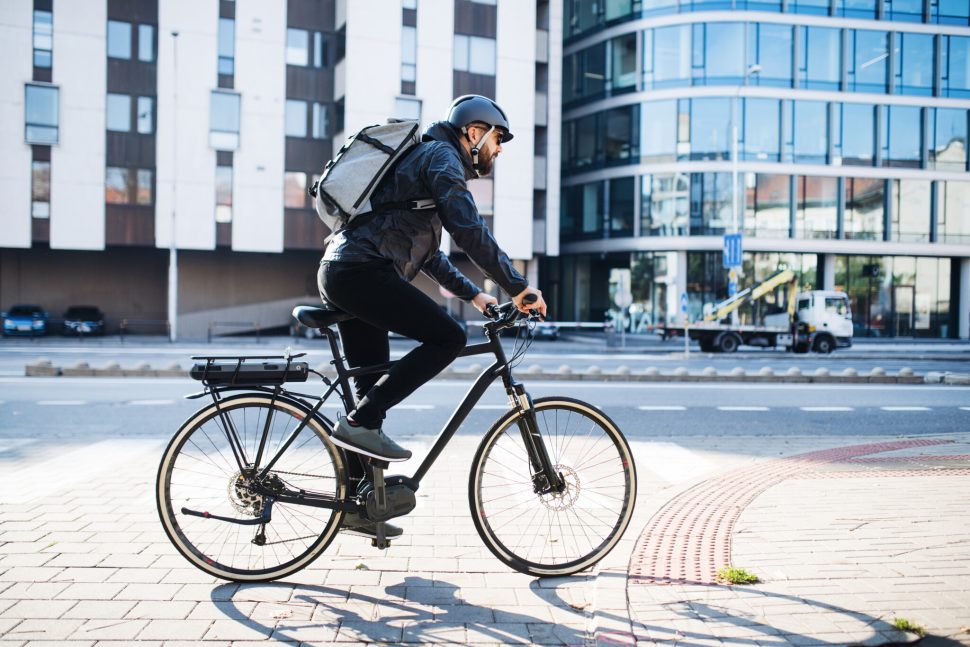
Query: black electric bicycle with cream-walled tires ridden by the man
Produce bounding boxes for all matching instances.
[156,303,637,582]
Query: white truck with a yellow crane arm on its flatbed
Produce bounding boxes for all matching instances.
[658,270,852,353]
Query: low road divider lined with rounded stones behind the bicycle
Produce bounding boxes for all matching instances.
[24,358,970,386]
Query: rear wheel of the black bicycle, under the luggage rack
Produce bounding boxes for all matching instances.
[155,393,347,582]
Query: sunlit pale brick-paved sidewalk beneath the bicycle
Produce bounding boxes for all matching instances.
[0,434,970,647]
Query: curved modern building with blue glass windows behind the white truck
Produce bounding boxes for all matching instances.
[544,0,970,338]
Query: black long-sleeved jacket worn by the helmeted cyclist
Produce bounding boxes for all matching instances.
[323,121,528,300]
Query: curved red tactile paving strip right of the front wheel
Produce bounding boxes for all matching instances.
[629,439,952,584]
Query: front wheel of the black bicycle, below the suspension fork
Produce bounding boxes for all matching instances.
[468,397,637,577]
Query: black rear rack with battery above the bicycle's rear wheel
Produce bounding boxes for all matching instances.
[189,353,310,386]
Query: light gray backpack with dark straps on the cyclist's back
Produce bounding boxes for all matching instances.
[307,120,421,232]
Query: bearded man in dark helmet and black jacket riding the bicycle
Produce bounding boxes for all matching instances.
[317,95,546,536]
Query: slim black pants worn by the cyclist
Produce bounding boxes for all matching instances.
[317,261,467,428]
